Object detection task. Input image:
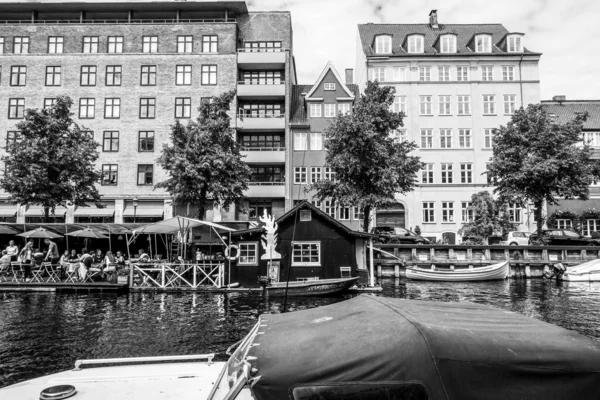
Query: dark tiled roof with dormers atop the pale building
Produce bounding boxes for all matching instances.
[358,24,540,57]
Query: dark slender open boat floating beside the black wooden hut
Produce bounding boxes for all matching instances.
[265,277,358,296]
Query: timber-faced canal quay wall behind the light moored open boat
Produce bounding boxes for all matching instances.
[373,244,600,278]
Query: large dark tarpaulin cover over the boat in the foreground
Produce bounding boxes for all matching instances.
[248,295,600,400]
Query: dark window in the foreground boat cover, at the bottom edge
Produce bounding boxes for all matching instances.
[292,382,429,400]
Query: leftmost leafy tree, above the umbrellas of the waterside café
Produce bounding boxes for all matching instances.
[0,96,102,221]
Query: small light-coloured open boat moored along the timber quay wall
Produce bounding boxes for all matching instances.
[406,262,509,282]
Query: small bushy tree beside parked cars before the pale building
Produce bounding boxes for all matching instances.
[458,190,514,244]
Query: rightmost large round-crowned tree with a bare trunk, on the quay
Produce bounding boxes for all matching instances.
[488,104,600,234]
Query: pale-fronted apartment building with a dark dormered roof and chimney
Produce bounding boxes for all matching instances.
[355,10,541,243]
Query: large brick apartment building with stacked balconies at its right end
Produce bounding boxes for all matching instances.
[0,1,295,223]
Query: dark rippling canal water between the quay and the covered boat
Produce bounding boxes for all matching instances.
[0,279,600,387]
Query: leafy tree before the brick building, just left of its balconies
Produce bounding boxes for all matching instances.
[156,91,250,219]
